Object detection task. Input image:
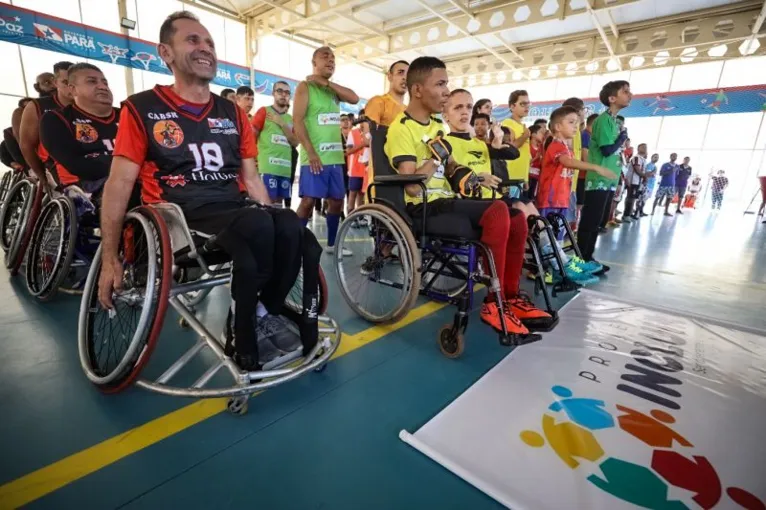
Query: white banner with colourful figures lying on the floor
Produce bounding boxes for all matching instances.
[401,292,766,510]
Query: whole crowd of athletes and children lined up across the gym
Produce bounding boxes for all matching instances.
[2,12,736,369]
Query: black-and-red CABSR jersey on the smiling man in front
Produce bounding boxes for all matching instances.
[115,85,255,219]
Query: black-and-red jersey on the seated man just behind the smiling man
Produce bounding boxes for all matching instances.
[40,104,119,191]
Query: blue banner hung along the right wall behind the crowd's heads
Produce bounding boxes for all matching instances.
[492,85,766,120]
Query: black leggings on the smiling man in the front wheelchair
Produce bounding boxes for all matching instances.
[187,206,303,356]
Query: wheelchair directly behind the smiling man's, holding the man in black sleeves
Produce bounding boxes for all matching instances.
[25,186,101,301]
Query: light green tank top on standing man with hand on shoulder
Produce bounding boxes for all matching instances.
[301,83,344,166]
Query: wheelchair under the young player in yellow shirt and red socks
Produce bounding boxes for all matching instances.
[335,122,557,358]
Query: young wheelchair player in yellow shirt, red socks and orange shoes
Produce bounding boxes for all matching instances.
[384,57,547,338]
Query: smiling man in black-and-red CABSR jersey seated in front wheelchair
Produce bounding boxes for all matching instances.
[98,11,314,371]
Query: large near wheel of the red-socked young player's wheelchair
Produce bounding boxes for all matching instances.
[335,204,421,323]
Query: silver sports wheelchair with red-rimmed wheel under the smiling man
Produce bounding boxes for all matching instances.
[78,203,341,414]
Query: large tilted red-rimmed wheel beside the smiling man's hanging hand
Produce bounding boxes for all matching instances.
[78,207,173,393]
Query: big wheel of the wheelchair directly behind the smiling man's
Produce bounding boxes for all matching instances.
[26,197,78,301]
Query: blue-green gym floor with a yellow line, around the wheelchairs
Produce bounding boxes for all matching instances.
[0,210,766,510]
